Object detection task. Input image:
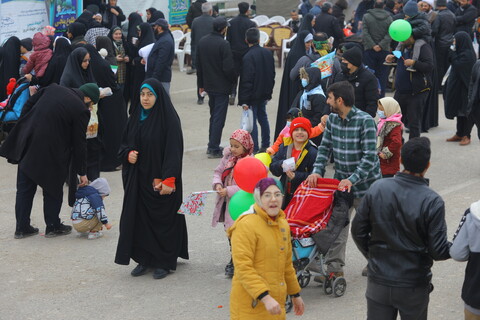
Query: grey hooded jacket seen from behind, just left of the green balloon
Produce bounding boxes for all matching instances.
[363,8,393,51]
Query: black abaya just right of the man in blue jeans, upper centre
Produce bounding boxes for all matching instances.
[275,30,309,137]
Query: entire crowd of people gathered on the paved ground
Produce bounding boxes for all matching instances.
[0,0,480,320]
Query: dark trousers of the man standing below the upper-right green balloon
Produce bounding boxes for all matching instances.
[393,91,429,139]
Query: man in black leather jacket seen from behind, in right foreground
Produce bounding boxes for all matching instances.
[352,137,451,320]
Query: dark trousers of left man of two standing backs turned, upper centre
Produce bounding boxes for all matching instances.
[207,91,228,152]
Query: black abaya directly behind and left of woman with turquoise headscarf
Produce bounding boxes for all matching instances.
[85,45,127,171]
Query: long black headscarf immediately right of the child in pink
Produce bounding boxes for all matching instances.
[39,37,72,87]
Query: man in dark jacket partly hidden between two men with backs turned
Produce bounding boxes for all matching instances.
[227,2,257,105]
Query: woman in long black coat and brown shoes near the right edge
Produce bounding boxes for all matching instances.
[444,31,477,145]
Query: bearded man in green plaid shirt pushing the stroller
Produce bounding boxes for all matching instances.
[307,81,382,281]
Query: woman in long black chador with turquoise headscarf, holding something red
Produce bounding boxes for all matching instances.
[115,79,188,279]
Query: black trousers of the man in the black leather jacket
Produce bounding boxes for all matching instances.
[365,279,430,320]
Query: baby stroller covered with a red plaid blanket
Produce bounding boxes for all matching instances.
[285,179,353,308]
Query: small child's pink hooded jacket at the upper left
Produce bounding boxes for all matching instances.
[22,32,53,78]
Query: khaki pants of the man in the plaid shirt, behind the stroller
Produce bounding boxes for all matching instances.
[325,198,362,273]
